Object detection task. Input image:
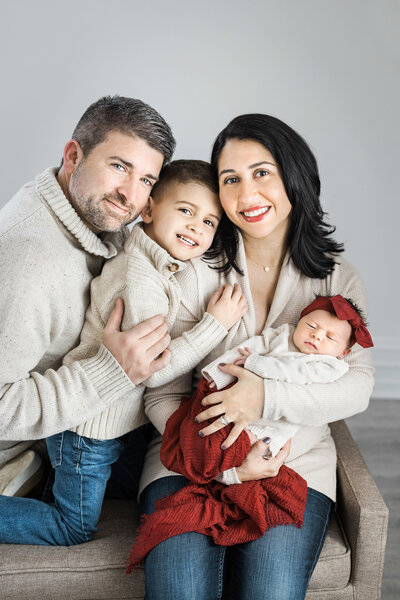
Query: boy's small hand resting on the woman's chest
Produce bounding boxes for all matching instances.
[207,283,248,329]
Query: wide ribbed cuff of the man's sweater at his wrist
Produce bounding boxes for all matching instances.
[79,344,135,406]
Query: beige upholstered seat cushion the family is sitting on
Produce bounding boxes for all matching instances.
[0,500,350,600]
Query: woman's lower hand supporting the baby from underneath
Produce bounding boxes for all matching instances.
[236,440,291,481]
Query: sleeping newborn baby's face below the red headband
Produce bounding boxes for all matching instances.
[293,310,352,358]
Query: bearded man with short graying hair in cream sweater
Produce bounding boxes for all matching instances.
[0,96,175,495]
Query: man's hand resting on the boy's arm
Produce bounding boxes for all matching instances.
[103,298,171,384]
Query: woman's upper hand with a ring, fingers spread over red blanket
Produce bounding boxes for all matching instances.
[196,363,264,450]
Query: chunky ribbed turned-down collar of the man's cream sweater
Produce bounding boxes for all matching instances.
[35,168,124,258]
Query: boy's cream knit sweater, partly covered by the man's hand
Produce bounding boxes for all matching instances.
[64,223,227,439]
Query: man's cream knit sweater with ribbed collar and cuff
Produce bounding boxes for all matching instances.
[0,169,131,463]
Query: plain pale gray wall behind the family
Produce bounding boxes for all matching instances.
[0,0,400,398]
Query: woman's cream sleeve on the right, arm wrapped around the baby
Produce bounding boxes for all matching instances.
[262,261,374,426]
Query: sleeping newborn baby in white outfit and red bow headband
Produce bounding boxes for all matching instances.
[202,295,373,460]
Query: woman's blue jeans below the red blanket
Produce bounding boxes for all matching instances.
[141,476,333,600]
